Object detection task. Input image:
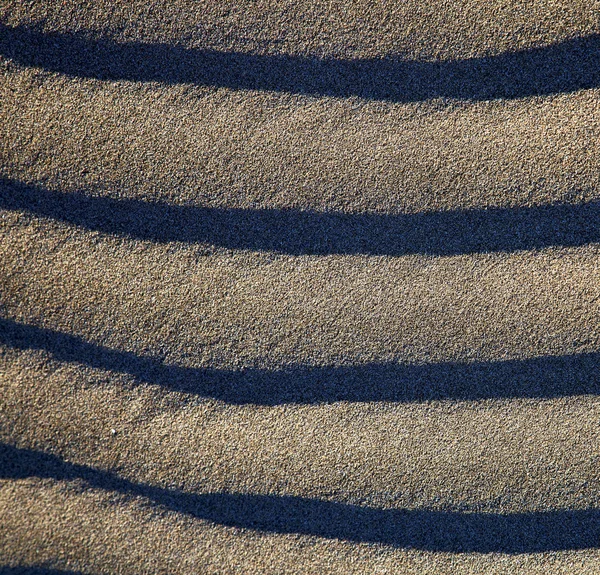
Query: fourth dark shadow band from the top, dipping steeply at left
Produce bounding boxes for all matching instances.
[0,444,600,553]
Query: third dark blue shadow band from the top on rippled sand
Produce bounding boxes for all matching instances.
[0,318,600,405]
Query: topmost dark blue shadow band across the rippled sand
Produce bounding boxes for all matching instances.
[0,24,600,102]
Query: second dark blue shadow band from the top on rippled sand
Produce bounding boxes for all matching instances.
[0,178,600,256]
